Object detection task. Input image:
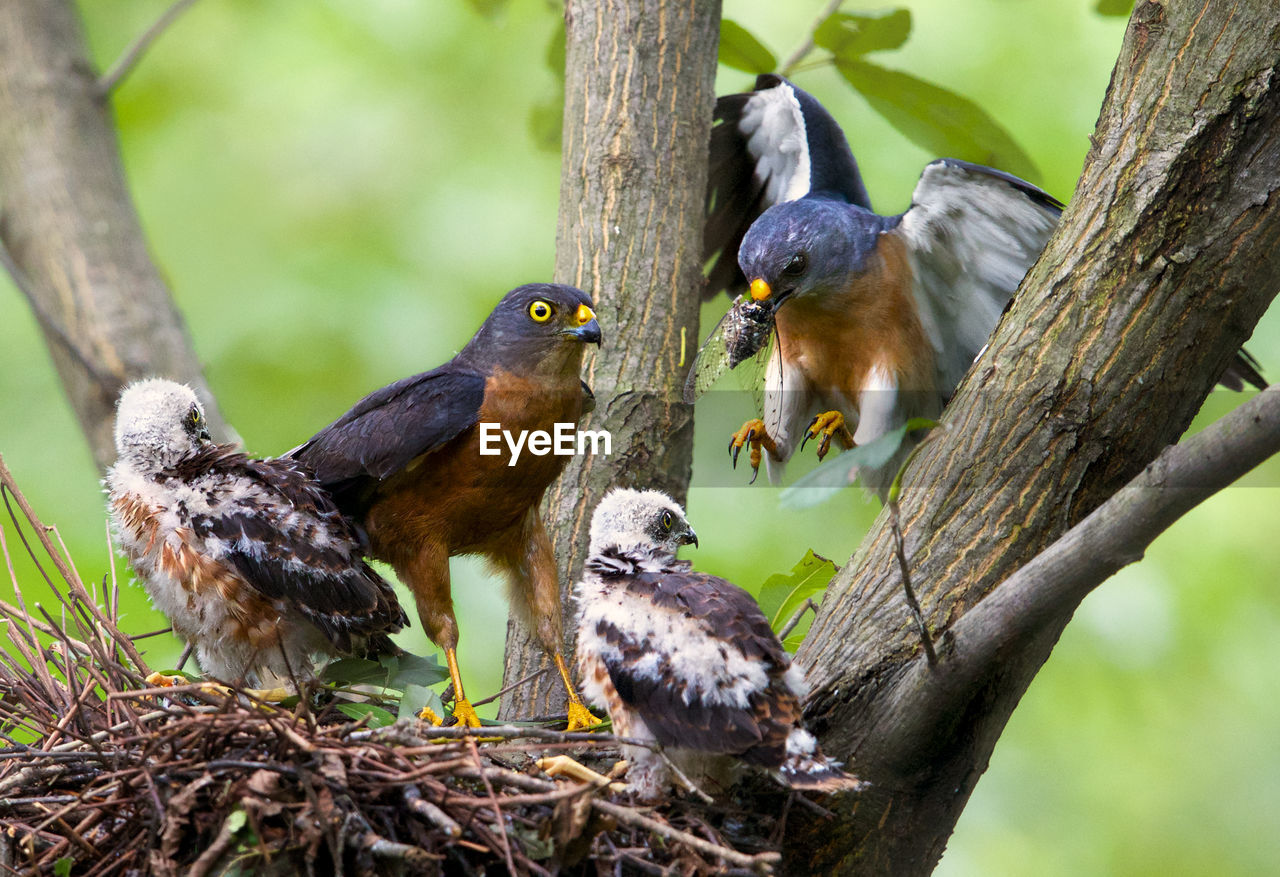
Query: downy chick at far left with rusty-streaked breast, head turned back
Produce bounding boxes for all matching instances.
[106,379,408,689]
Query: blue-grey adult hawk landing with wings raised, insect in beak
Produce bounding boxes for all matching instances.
[704,76,1265,494]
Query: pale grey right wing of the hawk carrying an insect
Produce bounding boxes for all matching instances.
[890,159,1062,396]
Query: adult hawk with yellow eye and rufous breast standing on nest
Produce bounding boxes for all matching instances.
[289,283,600,728]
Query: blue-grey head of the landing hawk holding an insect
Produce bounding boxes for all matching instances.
[737,197,886,312]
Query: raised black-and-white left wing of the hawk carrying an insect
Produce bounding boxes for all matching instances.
[703,74,870,297]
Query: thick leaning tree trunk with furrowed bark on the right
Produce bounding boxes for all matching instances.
[788,0,1280,874]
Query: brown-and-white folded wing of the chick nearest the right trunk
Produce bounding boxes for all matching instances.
[599,571,800,766]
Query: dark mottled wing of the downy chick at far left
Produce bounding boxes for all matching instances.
[180,446,408,652]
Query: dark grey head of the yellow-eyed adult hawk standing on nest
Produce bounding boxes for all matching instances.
[467,283,602,371]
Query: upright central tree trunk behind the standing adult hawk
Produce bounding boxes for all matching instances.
[502,0,719,717]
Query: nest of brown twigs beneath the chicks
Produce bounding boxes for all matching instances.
[0,460,790,876]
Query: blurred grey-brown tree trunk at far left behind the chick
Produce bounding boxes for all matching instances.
[0,0,227,466]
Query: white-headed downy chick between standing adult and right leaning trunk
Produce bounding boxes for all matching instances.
[576,489,859,799]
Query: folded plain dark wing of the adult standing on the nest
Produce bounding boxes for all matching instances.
[285,364,485,491]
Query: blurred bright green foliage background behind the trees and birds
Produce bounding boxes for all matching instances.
[0,0,1280,874]
